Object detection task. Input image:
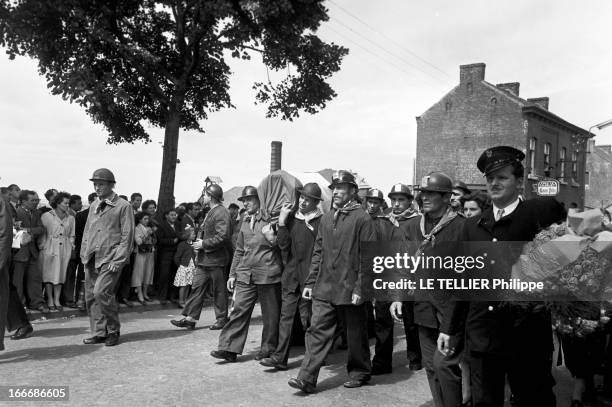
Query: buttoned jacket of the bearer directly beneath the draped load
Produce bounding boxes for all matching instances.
[230,213,282,284]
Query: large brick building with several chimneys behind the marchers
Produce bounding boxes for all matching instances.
[416,63,589,208]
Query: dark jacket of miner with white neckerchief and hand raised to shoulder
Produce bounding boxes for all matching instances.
[278,216,322,291]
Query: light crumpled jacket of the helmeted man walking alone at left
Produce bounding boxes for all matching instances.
[80,194,134,268]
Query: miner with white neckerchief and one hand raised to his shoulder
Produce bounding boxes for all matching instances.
[259,182,323,370]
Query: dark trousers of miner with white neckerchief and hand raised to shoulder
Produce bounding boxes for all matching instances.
[272,287,311,364]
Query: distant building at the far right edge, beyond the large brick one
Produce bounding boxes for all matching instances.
[584,140,612,208]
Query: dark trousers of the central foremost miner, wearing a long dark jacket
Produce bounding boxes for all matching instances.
[298,298,372,385]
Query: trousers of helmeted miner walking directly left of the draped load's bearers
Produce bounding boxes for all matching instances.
[183,266,227,323]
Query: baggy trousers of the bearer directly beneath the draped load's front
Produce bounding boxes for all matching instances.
[219,281,281,356]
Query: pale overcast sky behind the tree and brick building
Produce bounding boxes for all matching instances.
[0,0,612,202]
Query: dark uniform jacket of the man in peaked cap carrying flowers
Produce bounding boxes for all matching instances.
[443,198,566,353]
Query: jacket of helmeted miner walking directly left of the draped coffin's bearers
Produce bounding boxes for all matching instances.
[197,205,230,267]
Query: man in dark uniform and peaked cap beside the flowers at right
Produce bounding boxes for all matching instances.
[438,146,565,407]
